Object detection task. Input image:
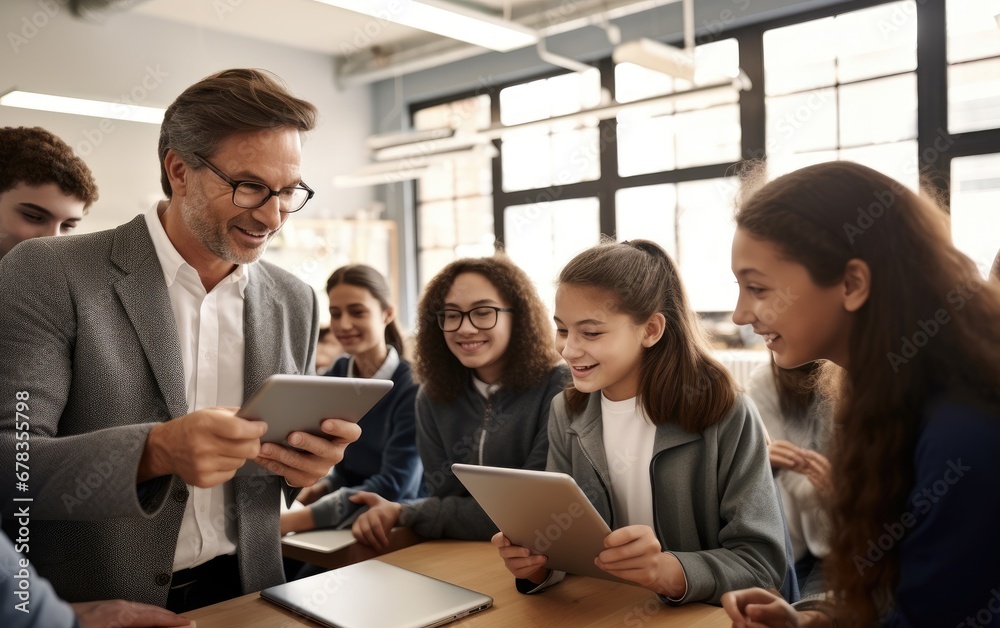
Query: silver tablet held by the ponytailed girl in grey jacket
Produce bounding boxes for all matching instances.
[451,463,622,582]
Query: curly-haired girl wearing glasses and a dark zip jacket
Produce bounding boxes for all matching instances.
[351,253,568,549]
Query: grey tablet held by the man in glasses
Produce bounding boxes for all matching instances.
[236,375,392,444]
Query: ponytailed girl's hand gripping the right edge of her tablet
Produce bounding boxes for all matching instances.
[594,525,687,599]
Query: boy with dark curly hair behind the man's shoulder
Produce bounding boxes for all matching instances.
[0,126,97,258]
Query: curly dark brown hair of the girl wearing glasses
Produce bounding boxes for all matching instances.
[413,253,559,403]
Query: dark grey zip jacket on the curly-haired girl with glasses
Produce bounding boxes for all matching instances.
[400,365,569,541]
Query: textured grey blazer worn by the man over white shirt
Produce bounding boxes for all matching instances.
[0,216,318,606]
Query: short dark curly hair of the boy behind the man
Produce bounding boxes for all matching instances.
[0,126,98,213]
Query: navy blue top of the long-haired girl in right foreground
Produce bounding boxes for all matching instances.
[884,397,1000,628]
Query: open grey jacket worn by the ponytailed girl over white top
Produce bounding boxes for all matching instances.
[546,394,787,604]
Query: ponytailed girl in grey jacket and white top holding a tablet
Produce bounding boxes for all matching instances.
[493,240,787,604]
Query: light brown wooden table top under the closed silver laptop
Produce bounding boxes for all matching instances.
[184,541,732,628]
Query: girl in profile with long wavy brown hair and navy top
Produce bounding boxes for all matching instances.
[723,162,1000,627]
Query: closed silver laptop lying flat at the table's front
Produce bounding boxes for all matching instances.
[260,559,493,628]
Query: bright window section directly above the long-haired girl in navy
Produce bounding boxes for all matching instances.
[764,0,919,188]
